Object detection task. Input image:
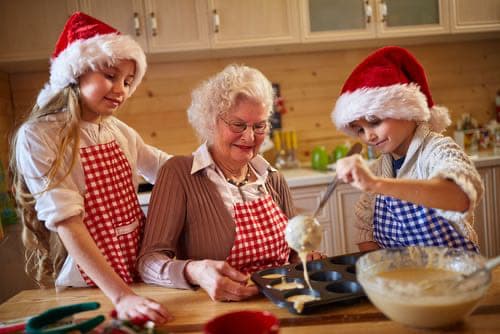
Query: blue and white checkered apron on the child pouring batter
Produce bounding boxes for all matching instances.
[373,195,479,252]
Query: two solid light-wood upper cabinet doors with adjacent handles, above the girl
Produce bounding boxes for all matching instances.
[73,0,209,53]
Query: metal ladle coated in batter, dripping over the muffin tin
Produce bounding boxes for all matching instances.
[285,143,363,253]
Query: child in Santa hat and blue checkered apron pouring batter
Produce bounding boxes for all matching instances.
[332,47,483,251]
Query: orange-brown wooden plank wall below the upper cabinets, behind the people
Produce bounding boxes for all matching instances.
[5,39,500,162]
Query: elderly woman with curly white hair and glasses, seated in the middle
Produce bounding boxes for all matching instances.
[138,65,317,300]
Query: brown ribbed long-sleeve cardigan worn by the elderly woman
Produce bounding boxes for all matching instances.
[137,156,295,289]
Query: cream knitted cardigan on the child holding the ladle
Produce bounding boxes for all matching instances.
[355,123,484,243]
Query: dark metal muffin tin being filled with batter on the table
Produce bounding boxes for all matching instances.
[252,253,366,314]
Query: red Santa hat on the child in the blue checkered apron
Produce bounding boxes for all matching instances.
[332,46,451,132]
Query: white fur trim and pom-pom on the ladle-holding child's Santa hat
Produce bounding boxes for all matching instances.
[331,83,451,133]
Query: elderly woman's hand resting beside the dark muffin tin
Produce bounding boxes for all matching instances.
[184,260,259,301]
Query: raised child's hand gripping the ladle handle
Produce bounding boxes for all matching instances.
[336,154,377,192]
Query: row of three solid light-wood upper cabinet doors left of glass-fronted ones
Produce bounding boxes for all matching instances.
[78,0,300,53]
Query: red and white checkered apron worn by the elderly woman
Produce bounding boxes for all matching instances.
[226,194,290,273]
